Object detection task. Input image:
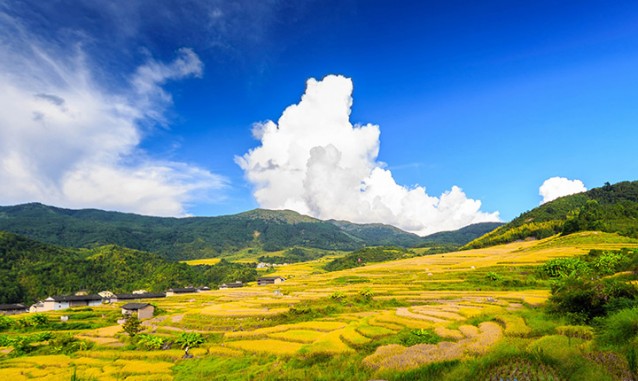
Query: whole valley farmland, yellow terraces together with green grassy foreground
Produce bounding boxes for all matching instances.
[0,232,638,381]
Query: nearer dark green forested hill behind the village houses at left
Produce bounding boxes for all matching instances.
[0,231,257,304]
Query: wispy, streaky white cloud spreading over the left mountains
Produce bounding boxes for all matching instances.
[0,12,226,216]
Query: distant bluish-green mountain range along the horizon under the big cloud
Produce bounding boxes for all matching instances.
[0,203,502,260]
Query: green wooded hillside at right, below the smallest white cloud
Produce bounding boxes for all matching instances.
[463,181,638,249]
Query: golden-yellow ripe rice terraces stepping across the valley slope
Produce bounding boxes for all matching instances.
[0,233,638,381]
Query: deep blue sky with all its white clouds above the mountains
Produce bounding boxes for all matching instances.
[0,0,638,235]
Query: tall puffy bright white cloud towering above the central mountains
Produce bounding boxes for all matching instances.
[235,75,499,235]
